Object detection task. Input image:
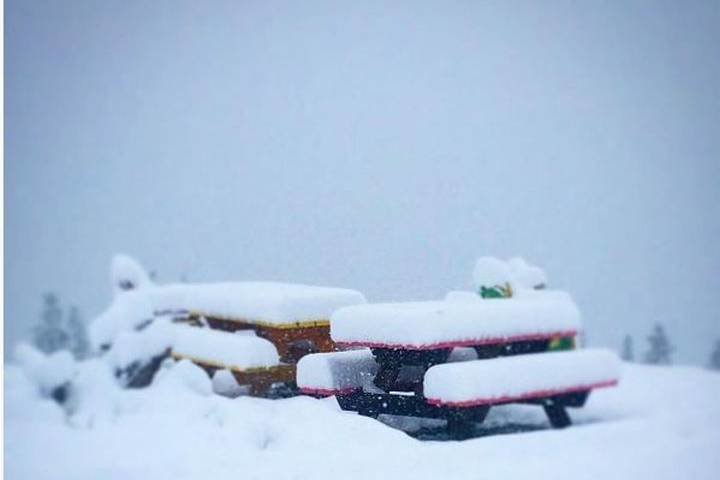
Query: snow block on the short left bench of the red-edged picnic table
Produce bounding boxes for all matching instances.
[297,348,378,395]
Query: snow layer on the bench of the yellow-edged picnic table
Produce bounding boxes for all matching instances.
[172,326,280,370]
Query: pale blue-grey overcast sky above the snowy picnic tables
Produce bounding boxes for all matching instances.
[5,0,720,362]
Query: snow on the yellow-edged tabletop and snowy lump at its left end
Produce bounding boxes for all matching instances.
[89,255,366,350]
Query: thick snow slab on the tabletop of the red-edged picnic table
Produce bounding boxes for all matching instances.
[330,290,580,349]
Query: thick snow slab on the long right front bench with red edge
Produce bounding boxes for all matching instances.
[424,349,620,406]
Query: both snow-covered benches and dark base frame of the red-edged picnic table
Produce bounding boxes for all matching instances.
[297,349,620,433]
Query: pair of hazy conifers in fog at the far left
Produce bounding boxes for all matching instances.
[33,293,90,360]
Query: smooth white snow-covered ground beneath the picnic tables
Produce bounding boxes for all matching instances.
[5,362,720,480]
